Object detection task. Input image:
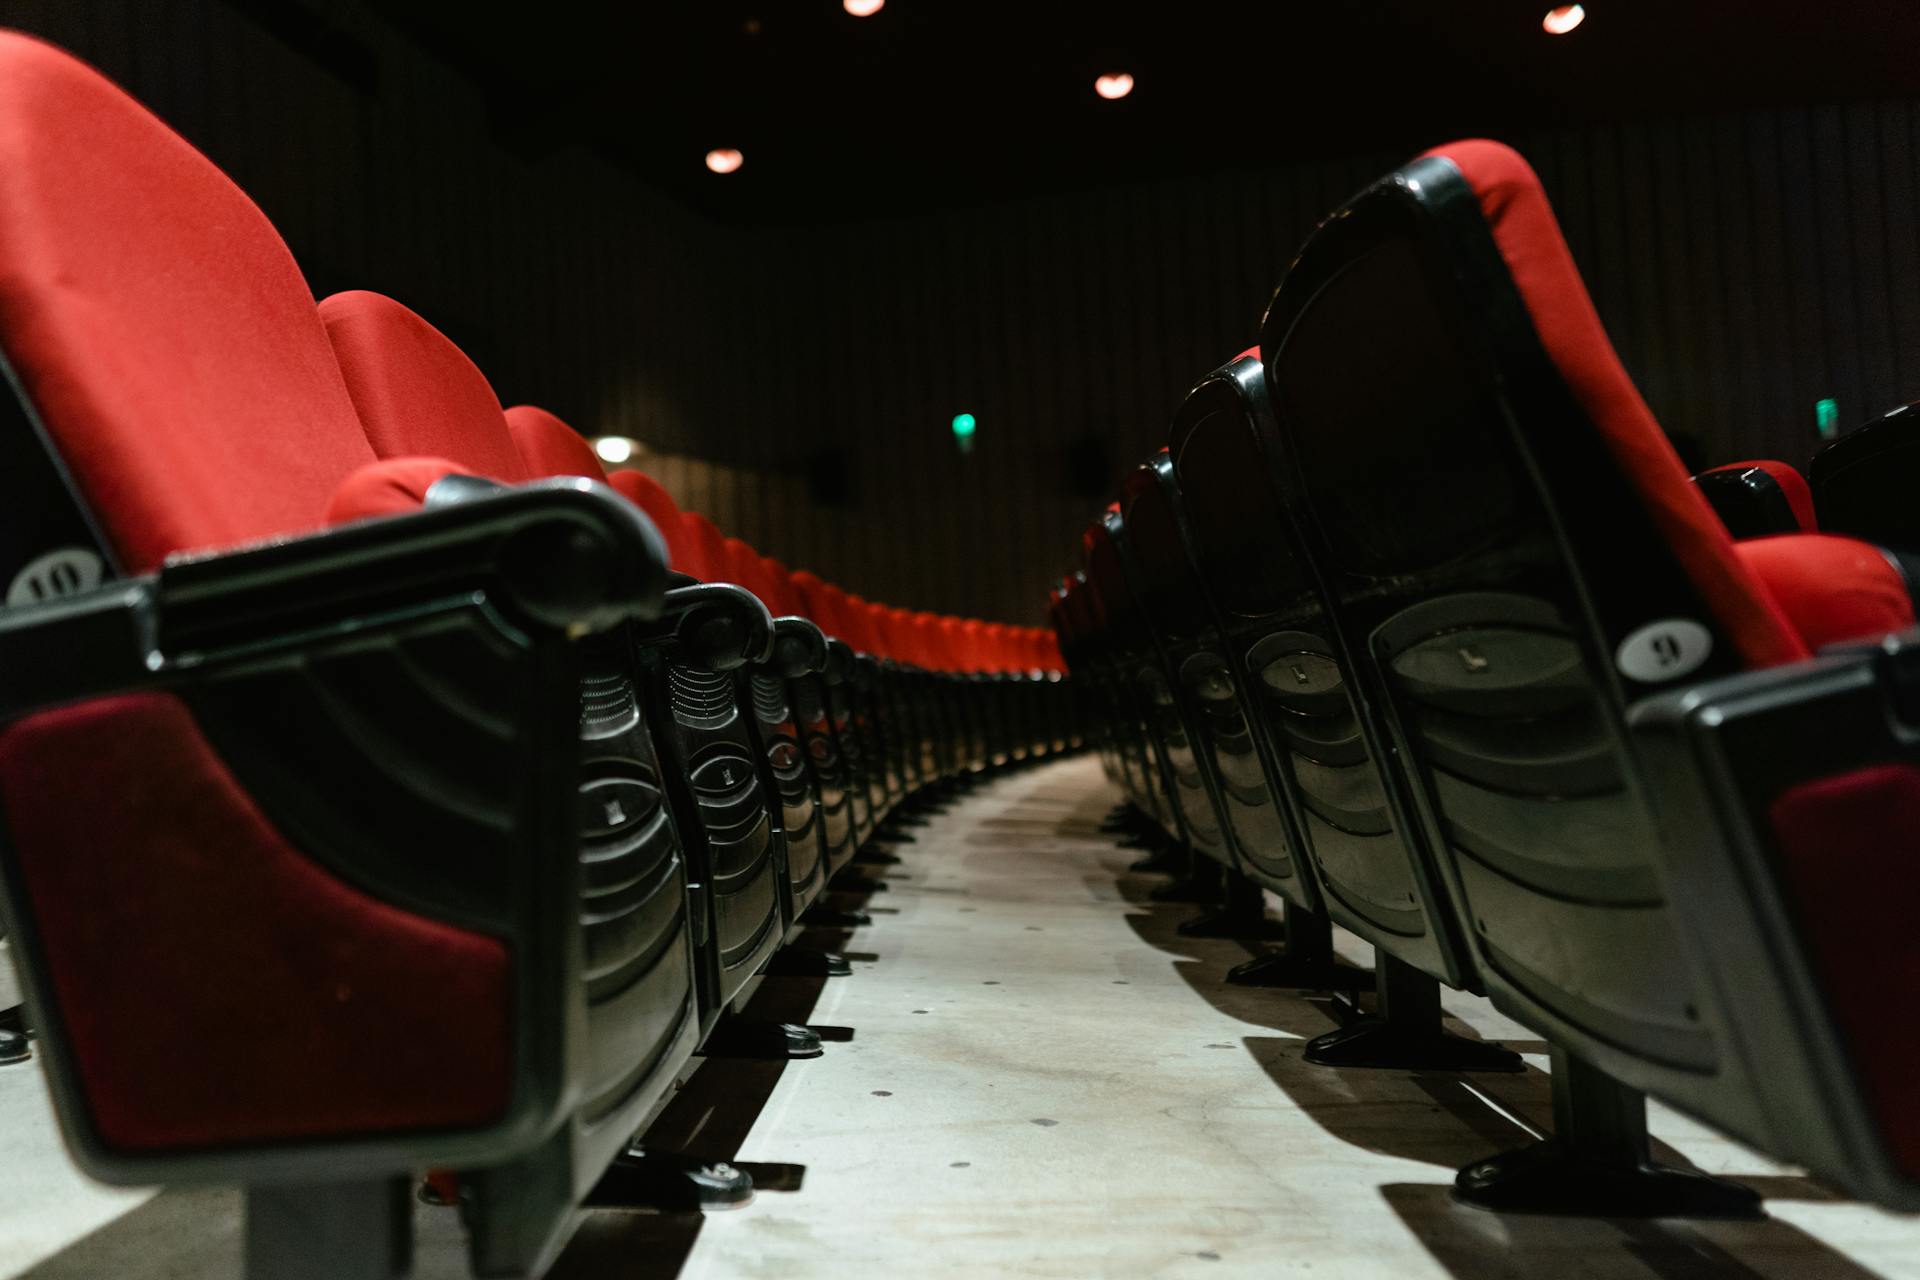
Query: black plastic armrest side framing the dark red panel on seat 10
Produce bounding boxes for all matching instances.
[0,480,666,1184]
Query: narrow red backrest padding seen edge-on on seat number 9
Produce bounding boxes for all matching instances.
[1428,140,1807,666]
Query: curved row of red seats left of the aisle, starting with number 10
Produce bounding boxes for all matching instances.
[0,33,1079,1278]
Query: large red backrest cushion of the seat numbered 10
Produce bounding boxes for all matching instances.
[0,33,372,572]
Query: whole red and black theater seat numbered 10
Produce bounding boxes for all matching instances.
[0,33,664,1278]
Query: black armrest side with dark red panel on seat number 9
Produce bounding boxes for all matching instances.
[1628,629,1920,1209]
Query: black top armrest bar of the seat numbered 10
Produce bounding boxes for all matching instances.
[0,478,666,718]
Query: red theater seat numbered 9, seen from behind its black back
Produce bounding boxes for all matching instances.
[1260,142,1910,1217]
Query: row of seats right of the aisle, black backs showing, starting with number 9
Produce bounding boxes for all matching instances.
[1052,142,1920,1217]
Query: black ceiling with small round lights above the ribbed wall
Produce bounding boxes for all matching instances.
[360,0,1920,223]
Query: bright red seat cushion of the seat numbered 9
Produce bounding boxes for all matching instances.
[1734,533,1914,649]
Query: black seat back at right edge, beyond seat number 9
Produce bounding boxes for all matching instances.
[1807,405,1920,553]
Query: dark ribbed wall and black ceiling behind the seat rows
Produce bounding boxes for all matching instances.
[15,0,1920,620]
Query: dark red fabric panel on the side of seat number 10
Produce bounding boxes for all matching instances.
[0,693,511,1151]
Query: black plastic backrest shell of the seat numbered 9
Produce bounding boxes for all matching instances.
[1261,144,1781,1107]
